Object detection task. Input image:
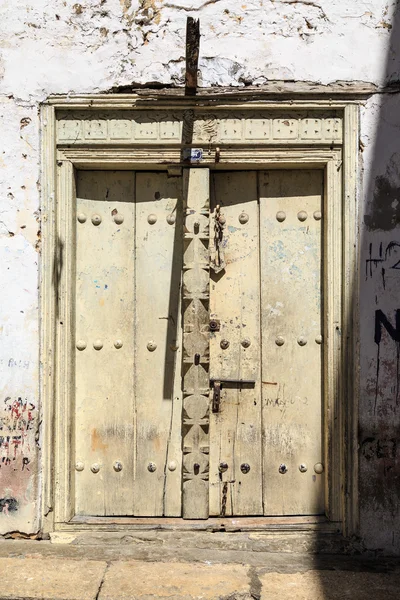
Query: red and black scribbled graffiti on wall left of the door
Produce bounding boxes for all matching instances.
[0,396,35,471]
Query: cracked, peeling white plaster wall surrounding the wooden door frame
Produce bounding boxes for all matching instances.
[0,0,400,552]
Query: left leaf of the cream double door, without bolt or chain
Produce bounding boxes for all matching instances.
[74,171,182,516]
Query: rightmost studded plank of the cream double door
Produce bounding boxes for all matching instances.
[260,170,325,515]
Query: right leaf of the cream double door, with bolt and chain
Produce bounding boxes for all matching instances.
[210,170,324,516]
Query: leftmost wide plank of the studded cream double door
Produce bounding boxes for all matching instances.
[72,171,135,516]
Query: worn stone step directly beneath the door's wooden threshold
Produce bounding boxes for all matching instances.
[46,519,362,565]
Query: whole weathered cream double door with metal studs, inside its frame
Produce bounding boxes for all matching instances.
[71,168,325,518]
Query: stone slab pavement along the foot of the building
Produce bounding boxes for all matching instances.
[0,540,400,600]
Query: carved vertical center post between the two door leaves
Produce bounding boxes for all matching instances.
[182,169,210,519]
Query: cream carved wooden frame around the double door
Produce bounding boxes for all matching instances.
[40,95,358,535]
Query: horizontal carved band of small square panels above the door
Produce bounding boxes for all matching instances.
[57,109,343,145]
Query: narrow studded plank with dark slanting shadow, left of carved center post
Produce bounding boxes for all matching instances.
[133,173,182,516]
